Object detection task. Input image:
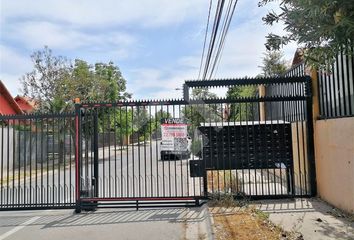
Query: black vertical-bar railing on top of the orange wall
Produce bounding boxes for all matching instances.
[318,49,354,119]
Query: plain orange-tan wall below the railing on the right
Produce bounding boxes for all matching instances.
[315,117,354,213]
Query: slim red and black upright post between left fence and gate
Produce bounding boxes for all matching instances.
[75,98,81,213]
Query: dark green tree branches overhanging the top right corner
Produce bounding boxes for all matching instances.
[259,0,354,65]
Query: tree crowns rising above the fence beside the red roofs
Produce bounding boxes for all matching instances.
[21,47,131,112]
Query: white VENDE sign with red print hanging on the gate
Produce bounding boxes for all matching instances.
[161,118,188,152]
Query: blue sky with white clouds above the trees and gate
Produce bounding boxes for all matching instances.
[0,0,296,99]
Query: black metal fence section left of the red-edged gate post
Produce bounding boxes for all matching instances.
[0,113,75,209]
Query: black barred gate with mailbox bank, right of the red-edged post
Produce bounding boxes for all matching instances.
[76,77,316,211]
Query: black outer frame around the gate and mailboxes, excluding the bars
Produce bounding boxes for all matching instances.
[75,76,317,213]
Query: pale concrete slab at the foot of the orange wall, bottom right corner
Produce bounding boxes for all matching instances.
[252,198,354,240]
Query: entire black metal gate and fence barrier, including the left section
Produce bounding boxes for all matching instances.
[0,77,316,211]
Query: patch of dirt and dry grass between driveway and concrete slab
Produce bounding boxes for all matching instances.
[209,207,302,240]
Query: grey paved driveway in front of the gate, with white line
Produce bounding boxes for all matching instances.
[0,206,211,240]
